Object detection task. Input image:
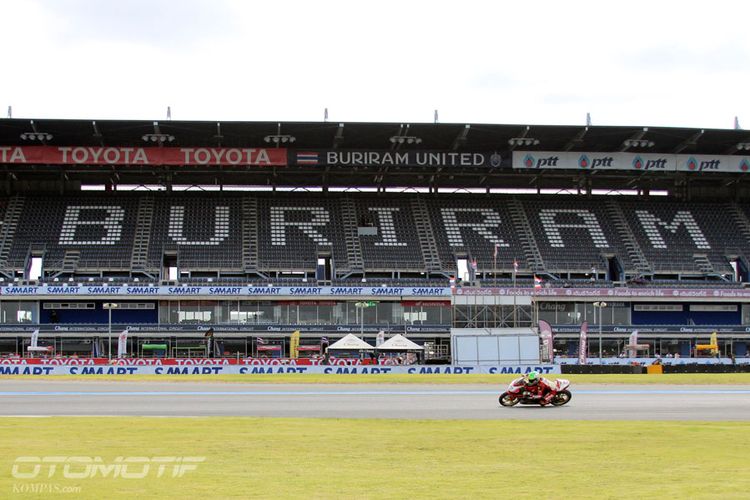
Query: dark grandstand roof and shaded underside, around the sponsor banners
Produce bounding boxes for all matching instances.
[0,119,750,196]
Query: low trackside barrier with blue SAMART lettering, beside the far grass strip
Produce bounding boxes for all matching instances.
[0,364,560,376]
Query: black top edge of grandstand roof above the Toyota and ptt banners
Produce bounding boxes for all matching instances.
[0,119,750,154]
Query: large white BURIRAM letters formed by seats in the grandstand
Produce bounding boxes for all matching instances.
[59,205,711,254]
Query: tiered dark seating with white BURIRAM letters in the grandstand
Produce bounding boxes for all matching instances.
[0,192,750,286]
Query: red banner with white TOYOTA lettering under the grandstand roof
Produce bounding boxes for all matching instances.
[0,146,287,167]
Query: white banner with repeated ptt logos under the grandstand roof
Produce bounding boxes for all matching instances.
[513,151,750,173]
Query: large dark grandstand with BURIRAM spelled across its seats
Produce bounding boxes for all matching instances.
[0,119,750,355]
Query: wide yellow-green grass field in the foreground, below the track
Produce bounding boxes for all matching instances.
[0,418,750,499]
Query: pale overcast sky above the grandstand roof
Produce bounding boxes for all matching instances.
[0,0,750,128]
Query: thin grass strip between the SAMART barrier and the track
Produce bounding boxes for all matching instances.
[0,373,750,385]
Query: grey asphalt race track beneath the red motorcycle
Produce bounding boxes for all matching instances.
[0,379,750,421]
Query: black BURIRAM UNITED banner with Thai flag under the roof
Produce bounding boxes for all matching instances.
[289,149,503,168]
